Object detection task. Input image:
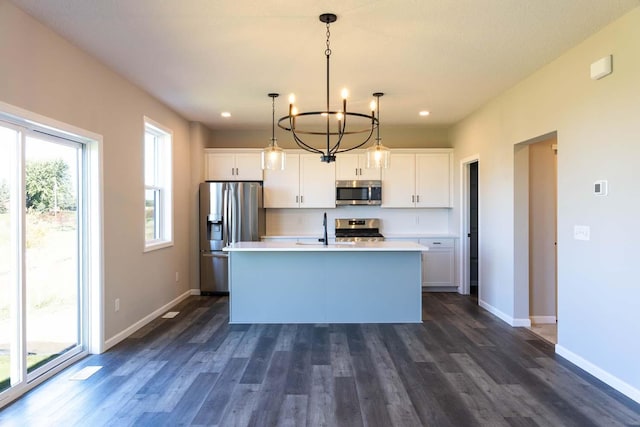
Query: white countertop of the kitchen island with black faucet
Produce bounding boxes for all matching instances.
[223,242,429,252]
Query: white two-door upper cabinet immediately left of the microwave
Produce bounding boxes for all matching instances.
[264,153,336,208]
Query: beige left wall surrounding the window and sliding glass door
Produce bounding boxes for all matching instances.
[0,0,193,340]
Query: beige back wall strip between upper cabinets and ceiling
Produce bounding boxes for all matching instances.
[207,123,451,148]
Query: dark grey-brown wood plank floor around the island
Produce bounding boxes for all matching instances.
[0,293,640,427]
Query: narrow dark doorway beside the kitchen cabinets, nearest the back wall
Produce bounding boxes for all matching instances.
[460,154,481,303]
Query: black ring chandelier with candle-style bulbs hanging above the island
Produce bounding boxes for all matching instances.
[278,13,389,168]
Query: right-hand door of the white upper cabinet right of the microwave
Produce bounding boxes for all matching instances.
[416,153,452,208]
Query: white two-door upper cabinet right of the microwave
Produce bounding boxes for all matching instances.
[382,149,453,208]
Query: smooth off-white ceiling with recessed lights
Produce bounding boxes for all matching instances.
[12,0,640,129]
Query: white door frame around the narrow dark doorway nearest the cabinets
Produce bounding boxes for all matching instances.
[458,153,482,301]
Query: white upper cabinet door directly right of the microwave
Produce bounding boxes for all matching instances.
[382,153,416,208]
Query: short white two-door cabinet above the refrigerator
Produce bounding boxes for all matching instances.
[204,149,262,181]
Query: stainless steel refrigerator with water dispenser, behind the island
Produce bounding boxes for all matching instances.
[200,182,265,295]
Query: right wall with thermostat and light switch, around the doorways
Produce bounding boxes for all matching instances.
[452,8,640,400]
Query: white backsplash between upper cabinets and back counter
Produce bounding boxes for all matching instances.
[266,206,455,236]
